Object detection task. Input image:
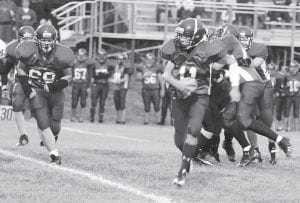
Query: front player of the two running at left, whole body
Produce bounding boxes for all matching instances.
[14,24,75,165]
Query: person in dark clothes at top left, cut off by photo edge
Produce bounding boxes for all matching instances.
[0,0,17,43]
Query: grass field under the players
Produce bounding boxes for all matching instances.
[0,120,300,203]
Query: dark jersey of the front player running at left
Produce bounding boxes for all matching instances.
[16,41,75,88]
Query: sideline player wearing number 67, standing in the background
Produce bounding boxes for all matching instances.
[71,48,95,122]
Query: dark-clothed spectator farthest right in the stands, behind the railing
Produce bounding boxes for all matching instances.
[268,0,291,23]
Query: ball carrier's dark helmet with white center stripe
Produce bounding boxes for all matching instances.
[175,18,207,51]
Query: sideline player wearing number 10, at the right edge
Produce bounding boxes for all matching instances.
[284,61,300,131]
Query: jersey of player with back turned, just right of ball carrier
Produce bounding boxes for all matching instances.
[220,35,262,84]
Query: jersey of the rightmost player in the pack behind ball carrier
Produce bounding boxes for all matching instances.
[247,42,271,82]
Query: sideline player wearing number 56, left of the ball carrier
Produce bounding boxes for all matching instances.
[136,53,164,125]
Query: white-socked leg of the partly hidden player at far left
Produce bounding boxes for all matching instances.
[12,82,29,146]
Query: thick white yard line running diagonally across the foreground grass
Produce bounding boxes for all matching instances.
[0,149,172,203]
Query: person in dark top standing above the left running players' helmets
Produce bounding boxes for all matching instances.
[16,0,37,29]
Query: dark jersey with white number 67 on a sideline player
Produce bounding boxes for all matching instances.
[72,59,95,85]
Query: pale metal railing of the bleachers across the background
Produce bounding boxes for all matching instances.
[52,0,300,57]
